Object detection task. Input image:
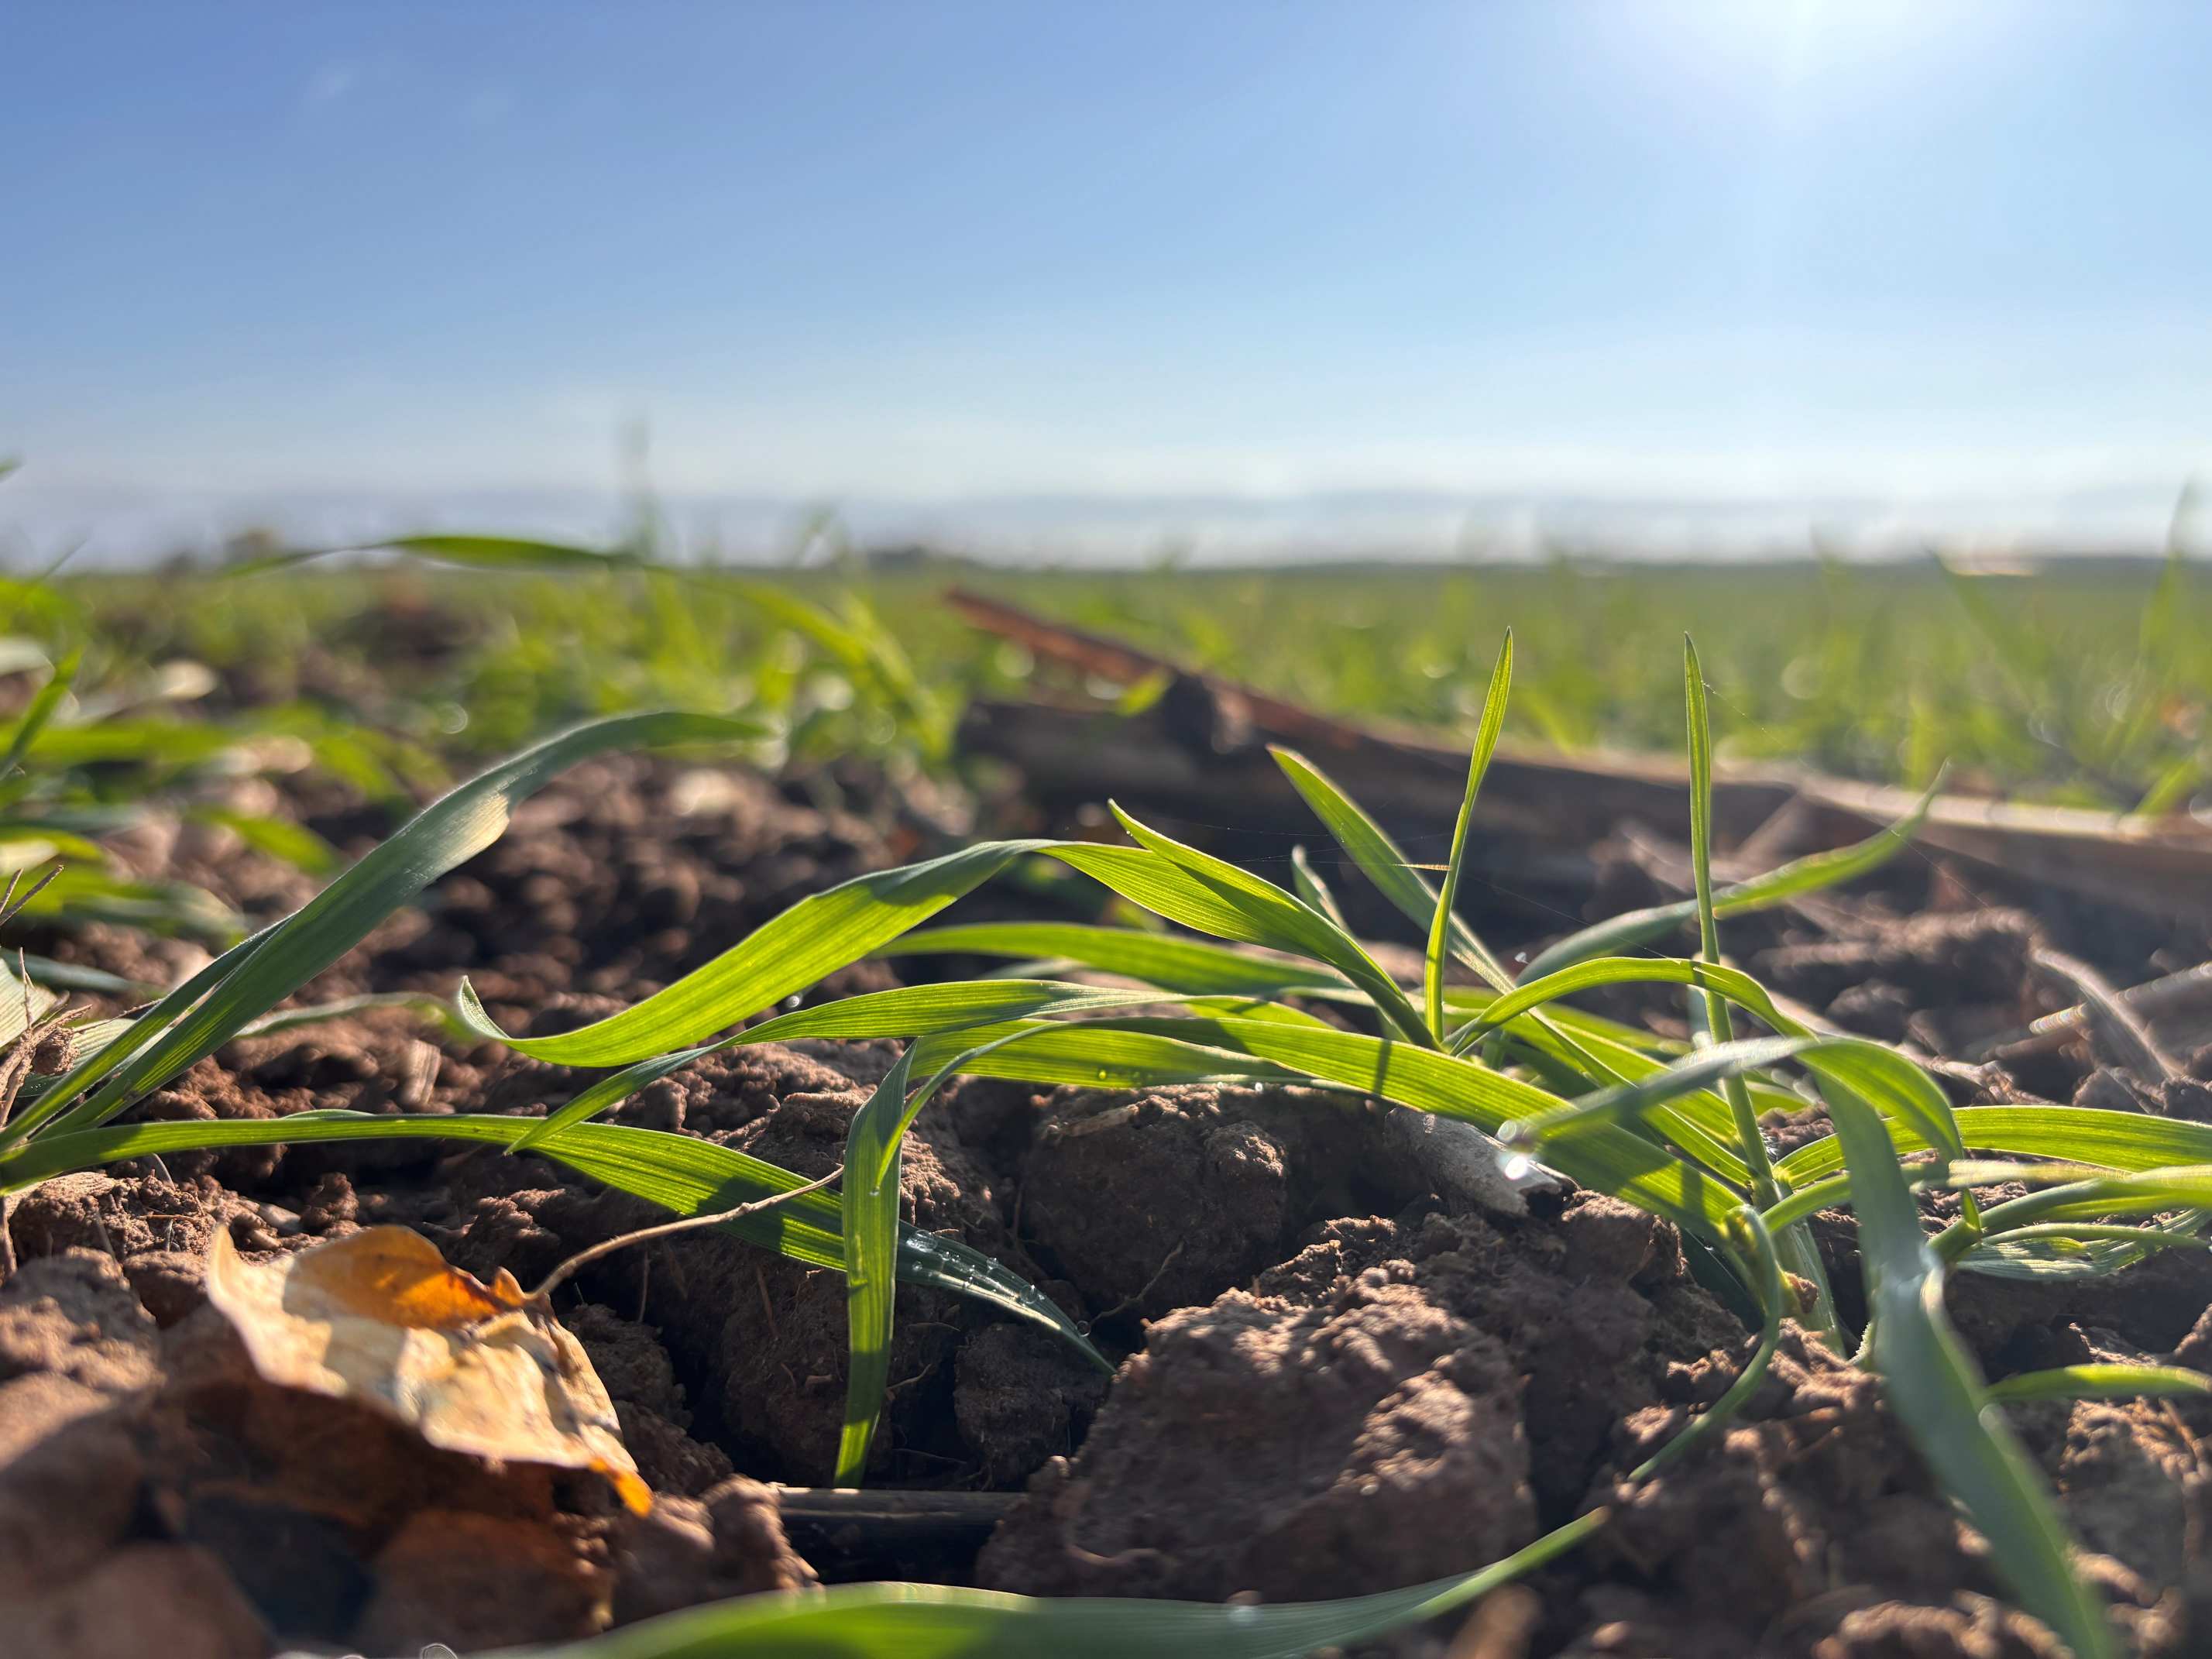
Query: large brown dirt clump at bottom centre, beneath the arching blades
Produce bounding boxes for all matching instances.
[977,1194,1732,1599]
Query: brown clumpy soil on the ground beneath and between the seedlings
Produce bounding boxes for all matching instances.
[0,721,2212,1659]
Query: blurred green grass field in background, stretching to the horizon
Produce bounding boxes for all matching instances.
[17,553,2212,812]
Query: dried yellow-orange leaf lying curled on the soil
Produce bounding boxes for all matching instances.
[208,1228,653,1513]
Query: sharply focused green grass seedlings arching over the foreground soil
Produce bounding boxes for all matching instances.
[0,606,2212,1659]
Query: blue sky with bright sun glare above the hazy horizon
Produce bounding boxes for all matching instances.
[0,0,2212,562]
